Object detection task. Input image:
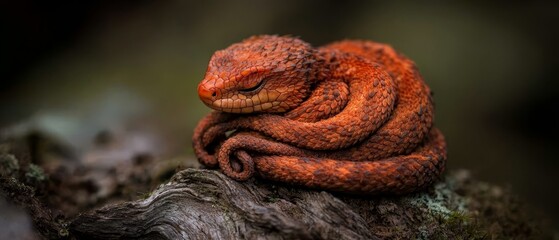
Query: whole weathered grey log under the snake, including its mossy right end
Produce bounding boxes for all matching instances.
[69,169,537,239]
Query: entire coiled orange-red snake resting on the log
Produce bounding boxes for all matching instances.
[193,36,446,194]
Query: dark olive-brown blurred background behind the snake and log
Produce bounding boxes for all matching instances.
[0,0,559,229]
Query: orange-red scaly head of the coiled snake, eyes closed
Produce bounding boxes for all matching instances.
[198,35,315,113]
